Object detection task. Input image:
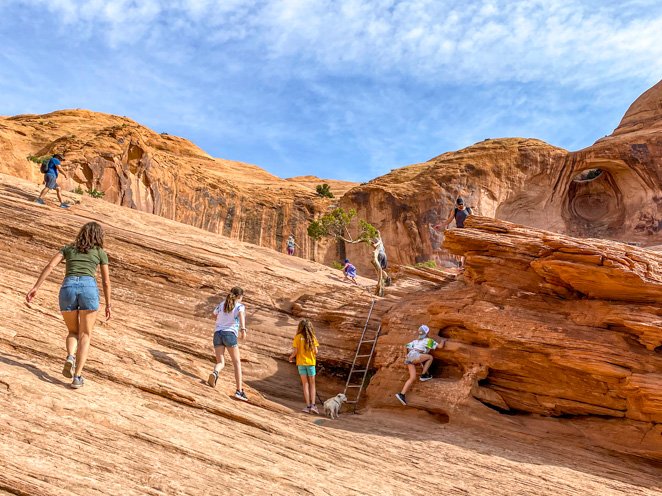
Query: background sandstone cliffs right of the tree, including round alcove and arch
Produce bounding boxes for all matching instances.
[334,82,662,271]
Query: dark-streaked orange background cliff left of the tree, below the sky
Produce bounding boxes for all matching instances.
[0,110,332,258]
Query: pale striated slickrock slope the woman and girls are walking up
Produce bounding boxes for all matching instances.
[0,175,661,496]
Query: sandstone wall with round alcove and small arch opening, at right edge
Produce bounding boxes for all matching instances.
[504,81,662,246]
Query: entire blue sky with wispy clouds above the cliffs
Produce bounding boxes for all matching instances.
[0,0,662,181]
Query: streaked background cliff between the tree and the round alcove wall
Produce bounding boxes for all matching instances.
[341,138,568,272]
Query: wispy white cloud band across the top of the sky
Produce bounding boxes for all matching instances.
[5,0,662,87]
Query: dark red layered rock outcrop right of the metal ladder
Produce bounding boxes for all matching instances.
[369,217,662,460]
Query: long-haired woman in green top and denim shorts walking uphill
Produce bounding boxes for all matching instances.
[25,222,110,389]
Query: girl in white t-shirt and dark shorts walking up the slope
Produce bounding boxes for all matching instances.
[207,286,248,401]
